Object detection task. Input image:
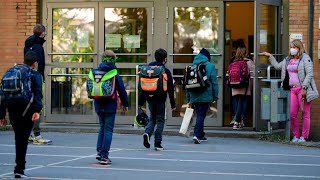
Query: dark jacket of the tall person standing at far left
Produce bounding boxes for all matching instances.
[23,35,46,77]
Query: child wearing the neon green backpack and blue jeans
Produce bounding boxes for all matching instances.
[91,50,129,165]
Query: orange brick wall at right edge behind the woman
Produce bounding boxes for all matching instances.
[289,0,320,141]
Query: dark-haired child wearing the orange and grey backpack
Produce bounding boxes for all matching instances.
[138,48,176,151]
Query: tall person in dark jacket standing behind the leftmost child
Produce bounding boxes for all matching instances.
[24,24,52,144]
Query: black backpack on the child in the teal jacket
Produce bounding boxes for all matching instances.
[183,62,209,91]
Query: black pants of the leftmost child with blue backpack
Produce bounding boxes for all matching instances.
[9,110,33,174]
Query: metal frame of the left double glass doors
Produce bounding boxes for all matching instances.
[42,0,154,124]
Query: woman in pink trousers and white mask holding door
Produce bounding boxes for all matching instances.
[263,39,319,143]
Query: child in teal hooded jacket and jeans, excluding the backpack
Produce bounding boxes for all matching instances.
[186,48,219,144]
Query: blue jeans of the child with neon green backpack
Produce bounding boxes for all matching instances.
[97,112,116,158]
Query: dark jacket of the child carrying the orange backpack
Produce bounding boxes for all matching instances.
[139,61,176,109]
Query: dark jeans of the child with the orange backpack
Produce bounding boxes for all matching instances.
[145,101,166,144]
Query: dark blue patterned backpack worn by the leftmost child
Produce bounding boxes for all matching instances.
[0,64,34,116]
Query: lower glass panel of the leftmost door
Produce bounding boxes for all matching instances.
[51,68,93,115]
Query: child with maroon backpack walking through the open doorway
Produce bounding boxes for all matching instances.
[227,46,253,130]
